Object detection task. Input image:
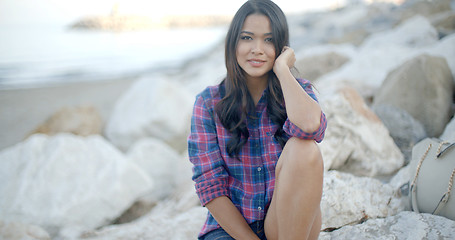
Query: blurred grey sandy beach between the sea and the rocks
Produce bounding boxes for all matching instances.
[0,78,136,149]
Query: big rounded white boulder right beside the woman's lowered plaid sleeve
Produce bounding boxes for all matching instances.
[105,77,194,151]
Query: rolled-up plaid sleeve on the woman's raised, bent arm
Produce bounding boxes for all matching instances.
[283,79,327,143]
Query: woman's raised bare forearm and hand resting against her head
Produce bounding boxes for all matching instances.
[273,47,321,133]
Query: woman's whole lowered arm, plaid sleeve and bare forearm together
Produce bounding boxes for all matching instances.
[188,92,258,239]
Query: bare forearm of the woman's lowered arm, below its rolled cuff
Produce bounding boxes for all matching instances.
[205,196,259,239]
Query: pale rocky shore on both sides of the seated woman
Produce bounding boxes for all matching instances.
[0,0,455,240]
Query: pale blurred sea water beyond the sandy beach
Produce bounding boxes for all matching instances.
[0,26,227,88]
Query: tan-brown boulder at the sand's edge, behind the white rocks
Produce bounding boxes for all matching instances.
[32,105,103,136]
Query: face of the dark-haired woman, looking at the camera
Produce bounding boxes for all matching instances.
[236,14,275,81]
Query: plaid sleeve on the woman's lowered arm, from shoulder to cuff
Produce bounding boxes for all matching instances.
[188,95,228,206]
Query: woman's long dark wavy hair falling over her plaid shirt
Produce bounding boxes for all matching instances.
[215,0,289,157]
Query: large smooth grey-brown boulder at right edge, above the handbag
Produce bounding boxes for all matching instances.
[374,54,454,137]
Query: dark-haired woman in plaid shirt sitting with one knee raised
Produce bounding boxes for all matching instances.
[188,0,326,240]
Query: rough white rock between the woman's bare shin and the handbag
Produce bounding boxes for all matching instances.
[321,171,404,229]
